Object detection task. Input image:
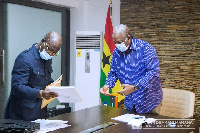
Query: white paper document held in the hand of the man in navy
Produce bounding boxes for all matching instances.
[48,86,83,103]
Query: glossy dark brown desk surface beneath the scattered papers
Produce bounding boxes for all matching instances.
[50,106,200,133]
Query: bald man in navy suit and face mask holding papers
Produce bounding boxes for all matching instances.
[5,31,62,121]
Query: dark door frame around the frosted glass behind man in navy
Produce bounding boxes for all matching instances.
[0,0,70,118]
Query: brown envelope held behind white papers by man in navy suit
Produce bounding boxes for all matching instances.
[41,75,62,109]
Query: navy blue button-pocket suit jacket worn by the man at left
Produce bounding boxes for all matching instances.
[5,44,53,121]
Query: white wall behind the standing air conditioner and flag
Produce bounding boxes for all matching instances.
[70,0,120,85]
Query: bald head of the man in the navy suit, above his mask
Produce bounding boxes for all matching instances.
[44,31,62,53]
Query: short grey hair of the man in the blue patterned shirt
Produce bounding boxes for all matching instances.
[113,24,130,38]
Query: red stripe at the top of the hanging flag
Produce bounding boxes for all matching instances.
[104,5,116,54]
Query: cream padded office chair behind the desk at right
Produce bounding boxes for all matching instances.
[160,88,195,118]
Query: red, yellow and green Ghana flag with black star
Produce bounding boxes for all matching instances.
[100,5,124,106]
